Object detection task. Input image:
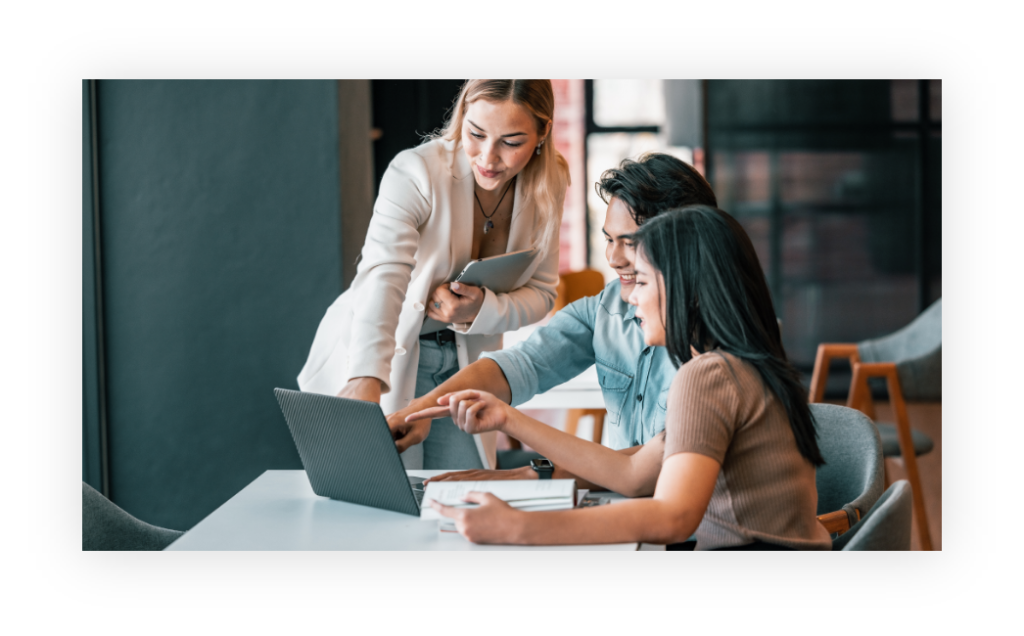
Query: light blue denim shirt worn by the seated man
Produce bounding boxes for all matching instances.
[480,280,676,450]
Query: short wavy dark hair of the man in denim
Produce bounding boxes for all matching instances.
[595,153,718,225]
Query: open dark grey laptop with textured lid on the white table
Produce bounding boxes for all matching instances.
[273,388,423,516]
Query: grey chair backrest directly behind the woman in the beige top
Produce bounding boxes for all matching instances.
[811,405,885,534]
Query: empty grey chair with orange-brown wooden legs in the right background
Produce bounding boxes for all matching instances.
[811,298,942,550]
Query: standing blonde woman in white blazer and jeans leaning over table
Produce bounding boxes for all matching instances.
[298,80,569,469]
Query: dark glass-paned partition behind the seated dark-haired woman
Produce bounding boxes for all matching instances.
[706,80,942,366]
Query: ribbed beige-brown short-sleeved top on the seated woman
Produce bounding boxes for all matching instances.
[665,350,831,550]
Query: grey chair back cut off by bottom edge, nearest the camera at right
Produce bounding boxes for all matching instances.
[833,479,913,552]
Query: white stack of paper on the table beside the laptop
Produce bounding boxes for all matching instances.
[420,479,577,520]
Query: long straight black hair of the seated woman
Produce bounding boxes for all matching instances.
[634,206,824,466]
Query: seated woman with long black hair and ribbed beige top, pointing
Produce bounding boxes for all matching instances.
[411,206,831,551]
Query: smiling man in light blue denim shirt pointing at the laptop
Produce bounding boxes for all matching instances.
[388,154,718,487]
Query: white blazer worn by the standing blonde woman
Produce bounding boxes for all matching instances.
[298,139,561,468]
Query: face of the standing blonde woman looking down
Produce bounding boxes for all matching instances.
[462,99,551,190]
